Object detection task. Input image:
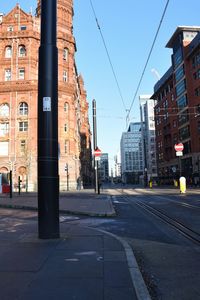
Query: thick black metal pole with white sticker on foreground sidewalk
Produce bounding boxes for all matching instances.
[38,0,60,239]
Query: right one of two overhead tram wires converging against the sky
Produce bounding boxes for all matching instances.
[126,0,169,124]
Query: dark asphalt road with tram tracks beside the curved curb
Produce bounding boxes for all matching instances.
[75,189,200,300]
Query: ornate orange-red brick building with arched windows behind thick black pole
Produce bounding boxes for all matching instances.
[0,0,91,190]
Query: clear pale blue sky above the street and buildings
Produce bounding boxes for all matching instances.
[0,0,200,171]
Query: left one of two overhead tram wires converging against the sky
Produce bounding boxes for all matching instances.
[90,0,127,112]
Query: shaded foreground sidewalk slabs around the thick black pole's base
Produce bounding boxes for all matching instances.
[0,212,141,300]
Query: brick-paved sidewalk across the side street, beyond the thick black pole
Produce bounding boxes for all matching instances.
[0,190,115,217]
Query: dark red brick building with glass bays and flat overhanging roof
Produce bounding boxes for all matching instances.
[151,26,200,182]
